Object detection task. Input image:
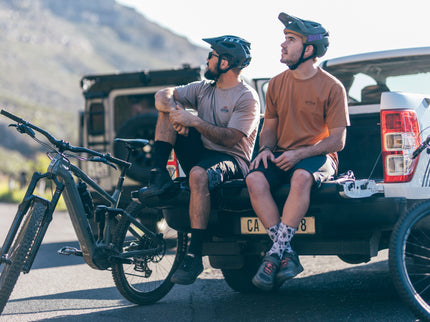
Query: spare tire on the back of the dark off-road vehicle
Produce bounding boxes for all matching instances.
[113,113,158,185]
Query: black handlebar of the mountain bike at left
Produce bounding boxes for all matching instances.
[0,109,131,168]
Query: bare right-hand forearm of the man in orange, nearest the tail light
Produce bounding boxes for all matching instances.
[275,127,346,171]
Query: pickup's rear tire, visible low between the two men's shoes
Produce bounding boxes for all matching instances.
[221,256,262,293]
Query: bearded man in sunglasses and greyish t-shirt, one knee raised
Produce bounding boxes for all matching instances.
[139,35,260,285]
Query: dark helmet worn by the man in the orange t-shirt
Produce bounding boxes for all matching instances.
[278,12,329,69]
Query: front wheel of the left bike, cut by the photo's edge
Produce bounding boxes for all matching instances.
[0,202,46,314]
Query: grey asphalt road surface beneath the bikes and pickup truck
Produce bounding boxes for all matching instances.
[0,204,416,322]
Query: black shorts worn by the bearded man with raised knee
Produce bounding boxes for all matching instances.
[174,128,243,191]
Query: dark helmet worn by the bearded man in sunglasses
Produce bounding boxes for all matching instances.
[203,35,251,69]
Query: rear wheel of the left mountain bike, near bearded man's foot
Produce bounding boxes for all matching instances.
[112,202,188,305]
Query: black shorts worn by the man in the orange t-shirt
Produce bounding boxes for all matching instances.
[250,152,336,191]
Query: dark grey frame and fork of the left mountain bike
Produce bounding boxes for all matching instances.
[0,153,161,273]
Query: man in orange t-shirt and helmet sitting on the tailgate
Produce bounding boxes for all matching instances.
[246,13,349,290]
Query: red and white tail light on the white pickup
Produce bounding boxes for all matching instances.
[381,110,421,182]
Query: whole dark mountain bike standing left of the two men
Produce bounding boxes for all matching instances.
[0,110,187,313]
